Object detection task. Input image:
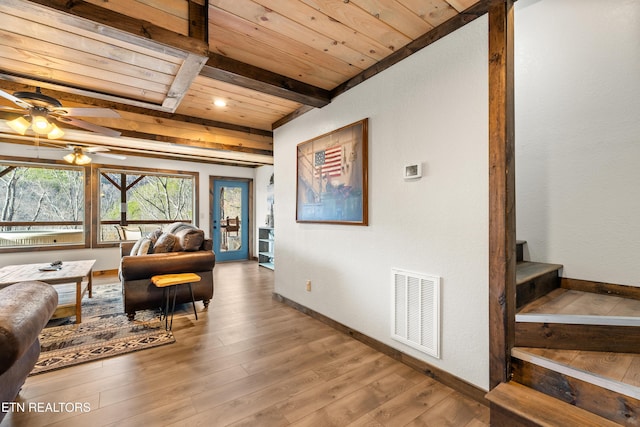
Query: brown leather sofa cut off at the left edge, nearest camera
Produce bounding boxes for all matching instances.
[0,282,58,421]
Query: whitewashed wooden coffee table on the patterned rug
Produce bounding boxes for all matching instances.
[0,259,96,323]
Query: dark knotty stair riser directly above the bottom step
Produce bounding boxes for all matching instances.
[512,359,640,425]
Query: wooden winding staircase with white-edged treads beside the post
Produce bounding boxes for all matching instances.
[487,241,640,426]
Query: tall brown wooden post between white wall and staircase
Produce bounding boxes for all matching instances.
[489,0,516,389]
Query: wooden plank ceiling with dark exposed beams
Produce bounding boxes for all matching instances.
[0,0,490,166]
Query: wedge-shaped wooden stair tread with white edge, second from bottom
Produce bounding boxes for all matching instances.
[511,347,640,399]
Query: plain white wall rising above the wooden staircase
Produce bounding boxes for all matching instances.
[515,0,640,286]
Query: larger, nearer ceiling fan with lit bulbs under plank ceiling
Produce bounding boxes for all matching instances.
[0,88,120,139]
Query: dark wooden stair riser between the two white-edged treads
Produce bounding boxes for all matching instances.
[515,323,640,353]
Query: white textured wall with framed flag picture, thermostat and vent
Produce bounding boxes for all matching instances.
[274,17,489,389]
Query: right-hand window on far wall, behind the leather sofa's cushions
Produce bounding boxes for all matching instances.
[96,168,197,243]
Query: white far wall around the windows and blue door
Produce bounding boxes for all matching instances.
[0,143,255,271]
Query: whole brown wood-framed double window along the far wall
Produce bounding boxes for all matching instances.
[0,157,198,253]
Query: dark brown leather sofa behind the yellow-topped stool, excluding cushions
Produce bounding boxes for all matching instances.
[120,226,215,320]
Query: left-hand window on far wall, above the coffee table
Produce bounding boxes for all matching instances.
[0,160,86,251]
